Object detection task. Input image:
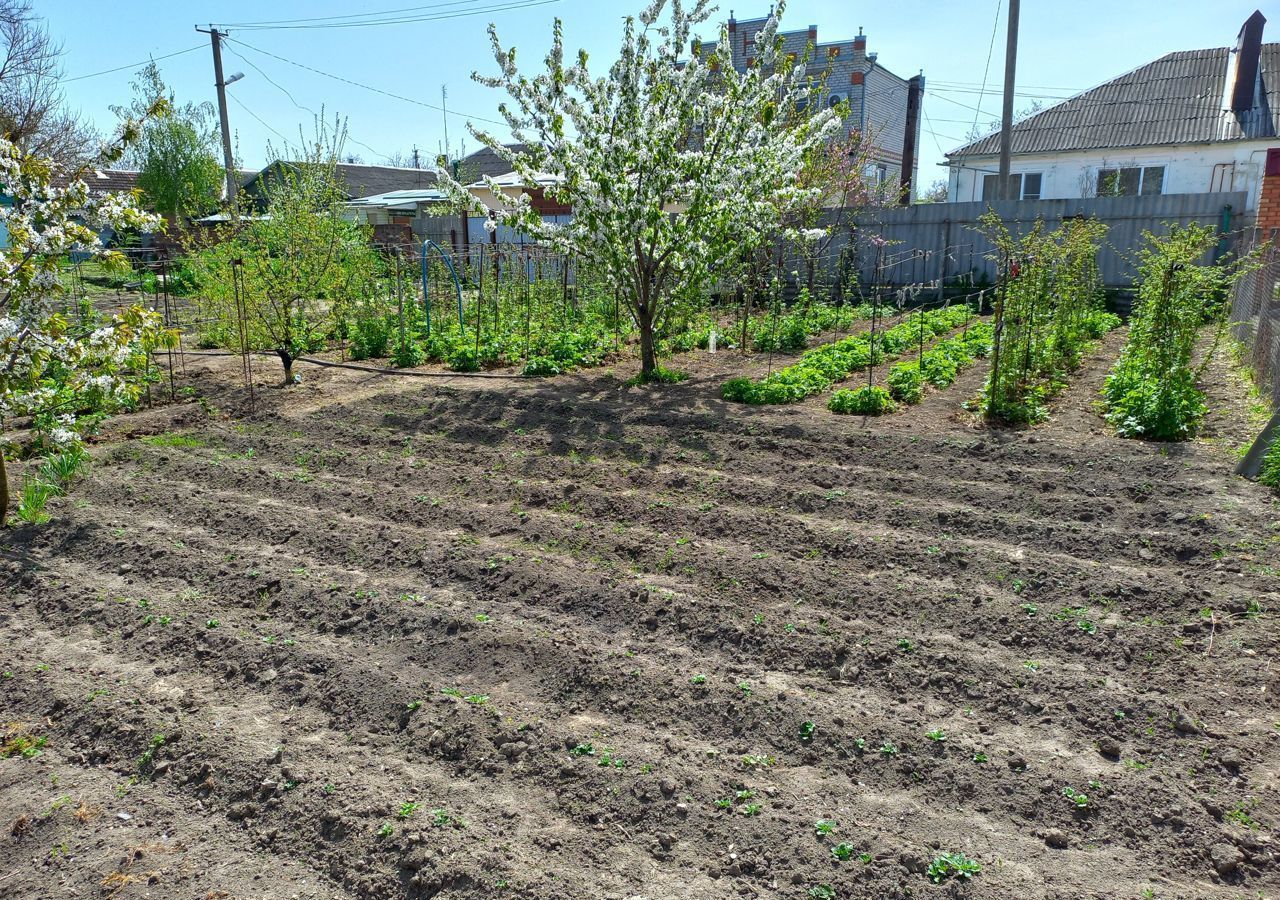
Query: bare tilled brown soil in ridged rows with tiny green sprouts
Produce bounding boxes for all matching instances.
[0,334,1280,900]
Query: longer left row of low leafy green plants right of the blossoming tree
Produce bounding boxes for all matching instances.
[721,306,973,403]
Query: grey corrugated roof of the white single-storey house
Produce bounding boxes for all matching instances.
[947,44,1280,156]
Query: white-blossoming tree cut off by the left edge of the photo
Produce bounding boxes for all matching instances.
[0,122,174,525]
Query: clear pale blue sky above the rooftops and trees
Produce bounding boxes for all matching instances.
[36,0,1280,193]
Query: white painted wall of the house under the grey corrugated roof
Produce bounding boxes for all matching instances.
[947,138,1280,214]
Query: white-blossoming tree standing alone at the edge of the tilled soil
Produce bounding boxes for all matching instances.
[440,0,838,380]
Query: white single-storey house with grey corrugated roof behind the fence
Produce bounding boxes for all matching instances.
[946,12,1280,217]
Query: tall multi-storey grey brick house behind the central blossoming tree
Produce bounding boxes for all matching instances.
[692,12,924,197]
